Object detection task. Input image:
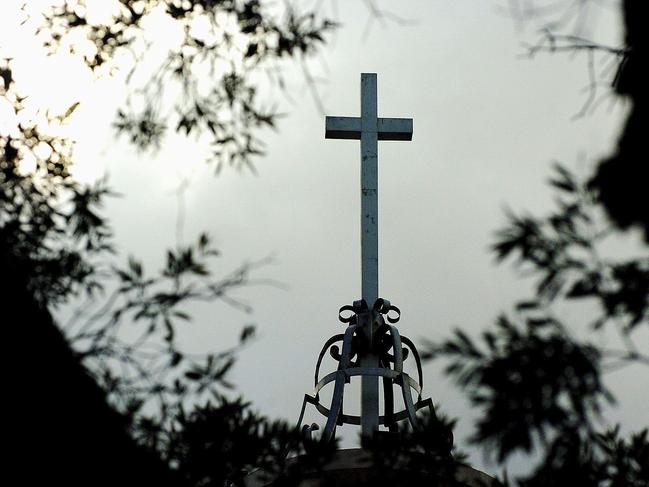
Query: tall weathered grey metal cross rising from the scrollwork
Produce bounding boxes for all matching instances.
[325,73,412,437]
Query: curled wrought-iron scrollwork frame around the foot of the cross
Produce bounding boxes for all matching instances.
[298,298,435,447]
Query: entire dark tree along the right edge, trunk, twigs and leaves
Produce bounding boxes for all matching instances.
[428,0,649,487]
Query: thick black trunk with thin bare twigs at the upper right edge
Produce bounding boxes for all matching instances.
[509,0,649,242]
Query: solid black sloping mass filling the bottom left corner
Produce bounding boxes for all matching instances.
[6,248,175,487]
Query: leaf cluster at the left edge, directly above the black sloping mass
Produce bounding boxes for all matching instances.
[0,60,113,305]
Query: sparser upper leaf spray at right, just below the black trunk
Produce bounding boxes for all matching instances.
[493,166,649,335]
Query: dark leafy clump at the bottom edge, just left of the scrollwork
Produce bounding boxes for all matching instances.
[160,398,336,487]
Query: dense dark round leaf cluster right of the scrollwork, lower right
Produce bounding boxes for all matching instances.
[430,316,612,461]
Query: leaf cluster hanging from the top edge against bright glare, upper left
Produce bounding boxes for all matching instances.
[39,0,336,170]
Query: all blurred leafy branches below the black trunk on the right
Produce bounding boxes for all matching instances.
[426,165,649,487]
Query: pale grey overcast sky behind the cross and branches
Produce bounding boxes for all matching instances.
[3,0,649,478]
